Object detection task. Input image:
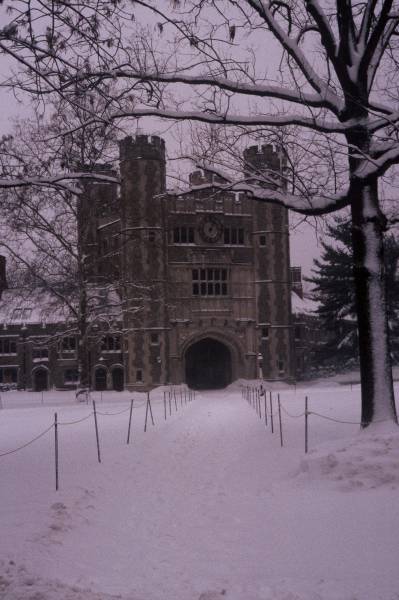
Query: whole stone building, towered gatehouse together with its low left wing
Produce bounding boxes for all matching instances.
[0,135,295,390]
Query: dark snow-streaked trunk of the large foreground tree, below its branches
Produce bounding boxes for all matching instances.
[351,180,397,427]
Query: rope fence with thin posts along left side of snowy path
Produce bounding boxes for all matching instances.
[0,386,195,491]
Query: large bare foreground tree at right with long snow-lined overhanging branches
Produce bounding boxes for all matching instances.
[0,0,399,426]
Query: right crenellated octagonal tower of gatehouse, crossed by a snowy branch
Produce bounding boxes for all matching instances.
[244,144,294,379]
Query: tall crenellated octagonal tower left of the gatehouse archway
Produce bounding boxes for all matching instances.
[120,135,168,389]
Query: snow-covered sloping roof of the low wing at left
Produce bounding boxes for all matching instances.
[0,286,121,325]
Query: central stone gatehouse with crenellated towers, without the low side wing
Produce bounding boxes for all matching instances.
[93,135,295,389]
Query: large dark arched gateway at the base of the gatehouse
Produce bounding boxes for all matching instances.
[185,338,231,390]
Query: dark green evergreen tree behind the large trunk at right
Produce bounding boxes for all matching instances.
[307,217,399,370]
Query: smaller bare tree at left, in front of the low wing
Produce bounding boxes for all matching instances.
[0,102,122,388]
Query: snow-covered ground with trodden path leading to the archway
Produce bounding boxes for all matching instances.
[0,385,399,600]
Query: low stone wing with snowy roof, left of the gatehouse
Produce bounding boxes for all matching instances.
[0,282,124,391]
